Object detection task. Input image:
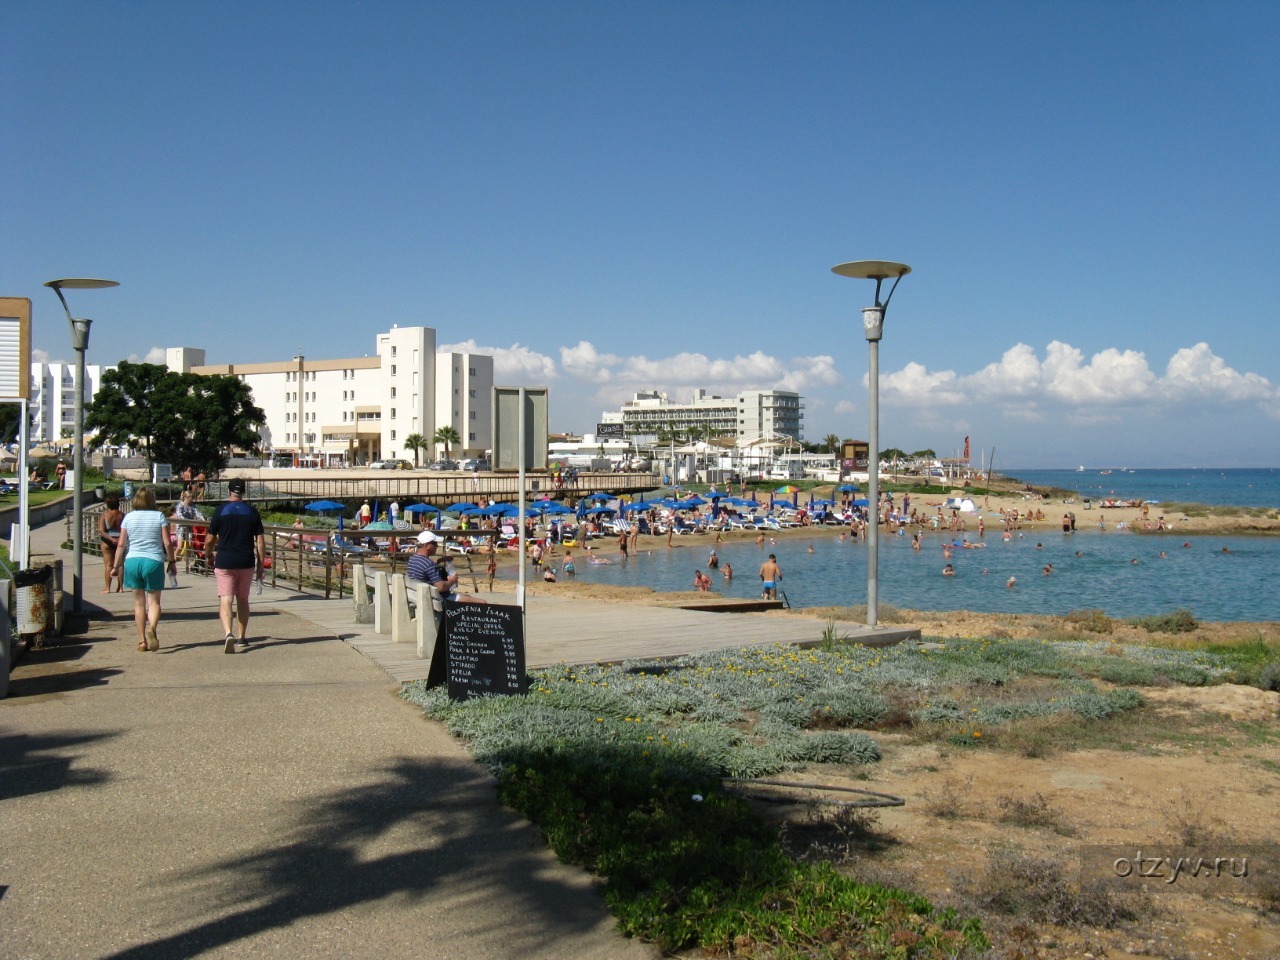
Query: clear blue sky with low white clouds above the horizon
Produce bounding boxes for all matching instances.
[0,0,1280,467]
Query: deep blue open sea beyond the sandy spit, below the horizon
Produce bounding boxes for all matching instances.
[1004,466,1280,508]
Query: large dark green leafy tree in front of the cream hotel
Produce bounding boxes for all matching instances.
[84,361,266,474]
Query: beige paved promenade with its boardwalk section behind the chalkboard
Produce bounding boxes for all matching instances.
[0,524,916,960]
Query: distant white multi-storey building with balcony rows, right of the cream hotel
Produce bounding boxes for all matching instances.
[600,389,804,440]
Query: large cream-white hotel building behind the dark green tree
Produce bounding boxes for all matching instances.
[165,326,493,465]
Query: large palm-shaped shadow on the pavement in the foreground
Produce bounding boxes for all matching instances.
[99,759,619,960]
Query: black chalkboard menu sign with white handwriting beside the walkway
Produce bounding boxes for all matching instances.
[426,603,529,700]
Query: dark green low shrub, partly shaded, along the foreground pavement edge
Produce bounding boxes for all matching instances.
[498,751,987,957]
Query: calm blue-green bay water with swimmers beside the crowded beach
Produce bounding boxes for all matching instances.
[557,527,1280,621]
